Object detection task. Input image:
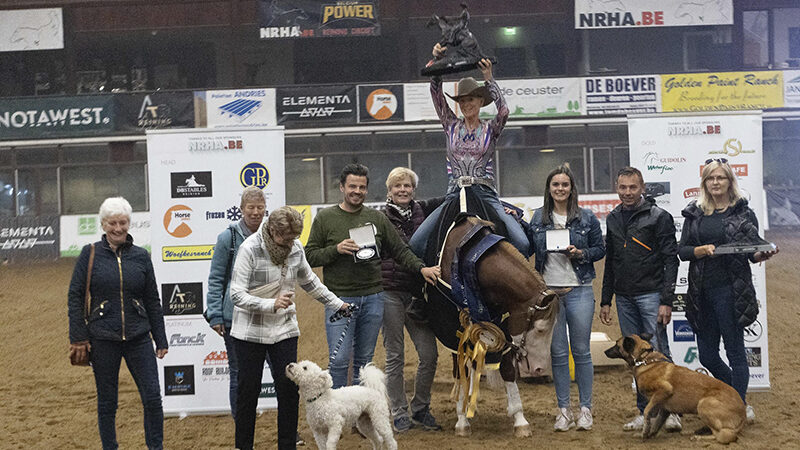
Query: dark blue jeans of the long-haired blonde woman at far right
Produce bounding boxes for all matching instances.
[696,284,750,404]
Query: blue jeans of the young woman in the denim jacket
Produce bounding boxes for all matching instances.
[550,283,594,408]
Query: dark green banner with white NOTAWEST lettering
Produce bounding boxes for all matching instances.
[0,95,114,140]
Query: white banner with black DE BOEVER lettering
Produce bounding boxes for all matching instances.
[582,75,661,116]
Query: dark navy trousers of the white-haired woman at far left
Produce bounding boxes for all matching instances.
[91,333,164,450]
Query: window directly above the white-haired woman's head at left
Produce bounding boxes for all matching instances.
[61,164,147,214]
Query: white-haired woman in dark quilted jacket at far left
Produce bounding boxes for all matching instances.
[69,197,167,450]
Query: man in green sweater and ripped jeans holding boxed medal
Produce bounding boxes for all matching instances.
[306,164,440,389]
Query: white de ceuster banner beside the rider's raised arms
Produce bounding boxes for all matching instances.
[478,78,586,119]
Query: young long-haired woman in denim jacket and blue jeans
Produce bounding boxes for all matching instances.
[528,165,606,431]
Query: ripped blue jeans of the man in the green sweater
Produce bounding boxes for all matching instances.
[325,292,383,389]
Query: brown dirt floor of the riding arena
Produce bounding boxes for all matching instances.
[0,232,800,450]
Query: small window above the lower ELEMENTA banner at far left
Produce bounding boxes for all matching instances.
[17,167,57,216]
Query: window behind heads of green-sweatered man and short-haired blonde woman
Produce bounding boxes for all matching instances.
[325,152,408,203]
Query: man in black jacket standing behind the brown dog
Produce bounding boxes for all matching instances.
[600,167,681,431]
